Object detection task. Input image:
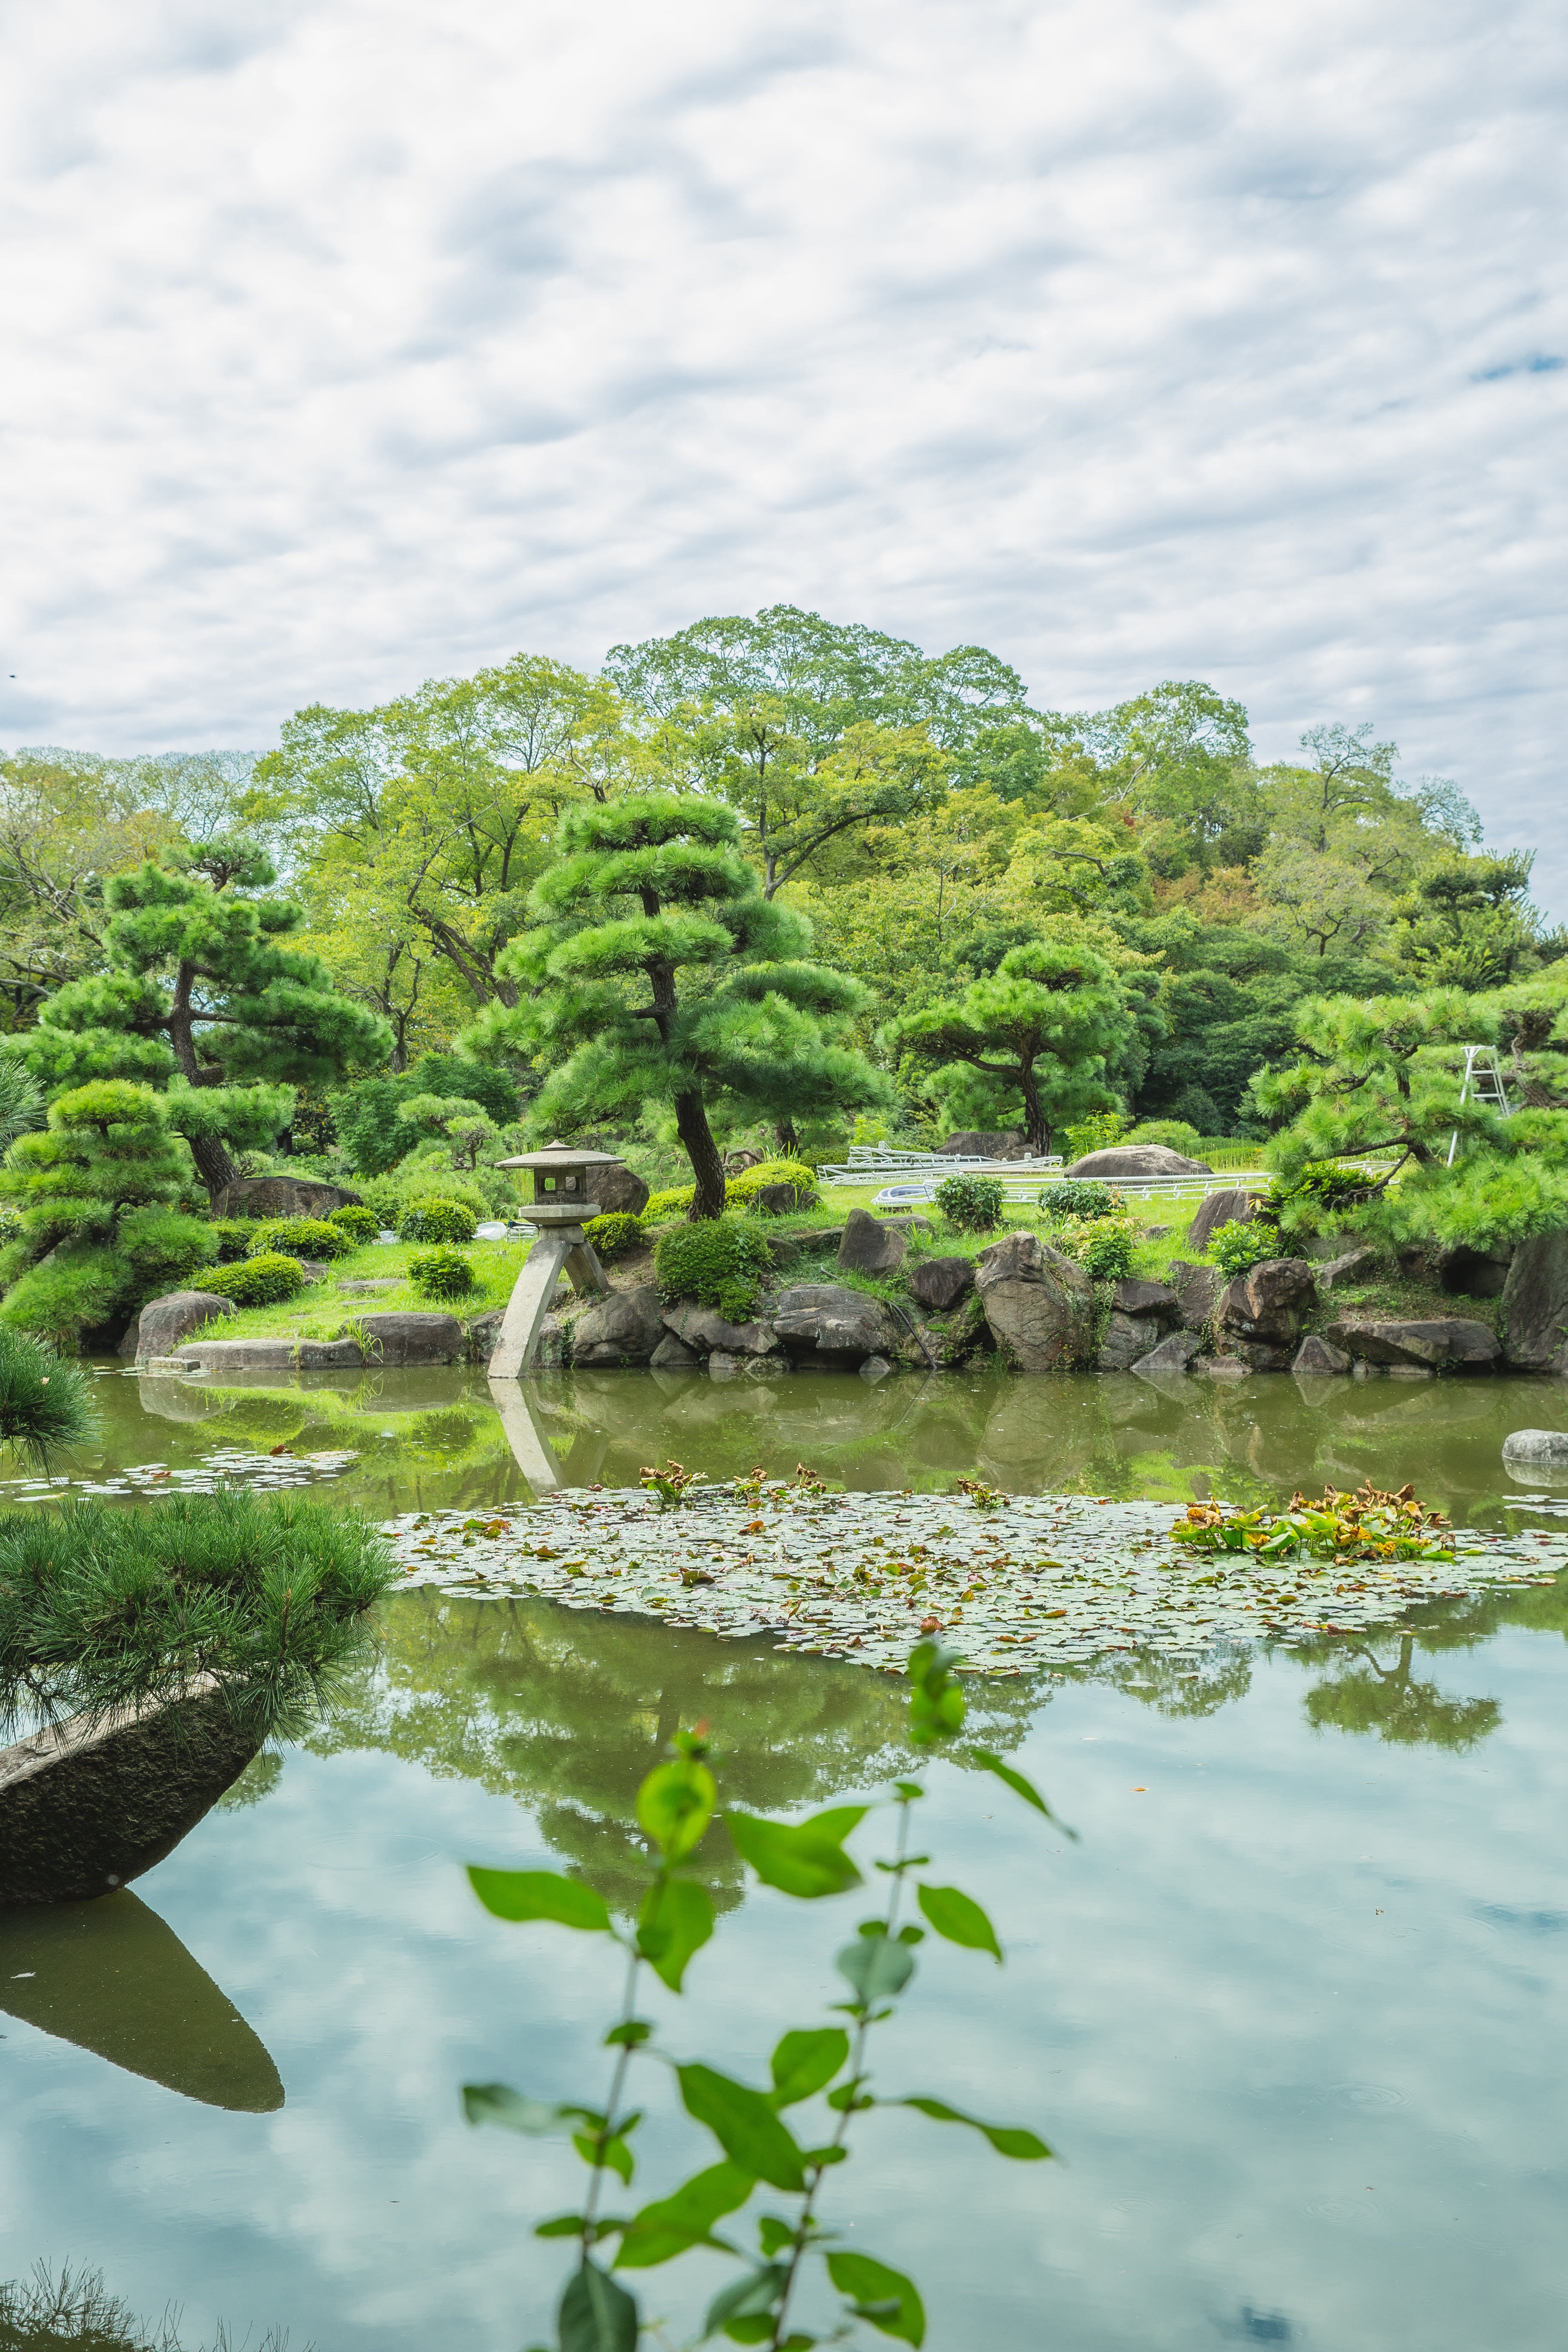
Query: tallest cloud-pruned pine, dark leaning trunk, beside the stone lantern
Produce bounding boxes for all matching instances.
[461,793,886,1218]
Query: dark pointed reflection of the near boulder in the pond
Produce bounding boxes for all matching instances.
[0,1889,282,2116]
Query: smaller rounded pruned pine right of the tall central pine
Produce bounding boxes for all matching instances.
[882,938,1138,1157]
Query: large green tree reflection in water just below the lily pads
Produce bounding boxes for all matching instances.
[310,1588,1046,1908]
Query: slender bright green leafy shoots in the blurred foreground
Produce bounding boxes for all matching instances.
[463,1642,1051,2352]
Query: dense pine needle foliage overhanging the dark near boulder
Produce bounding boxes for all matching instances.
[0,1494,392,1736]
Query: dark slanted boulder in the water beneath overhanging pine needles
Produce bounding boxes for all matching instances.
[0,1675,261,1905]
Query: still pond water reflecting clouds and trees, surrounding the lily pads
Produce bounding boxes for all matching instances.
[0,1371,1568,2352]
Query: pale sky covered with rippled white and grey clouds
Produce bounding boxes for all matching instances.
[0,0,1568,894]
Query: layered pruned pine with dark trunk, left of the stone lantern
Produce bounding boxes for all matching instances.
[24,844,392,1202]
